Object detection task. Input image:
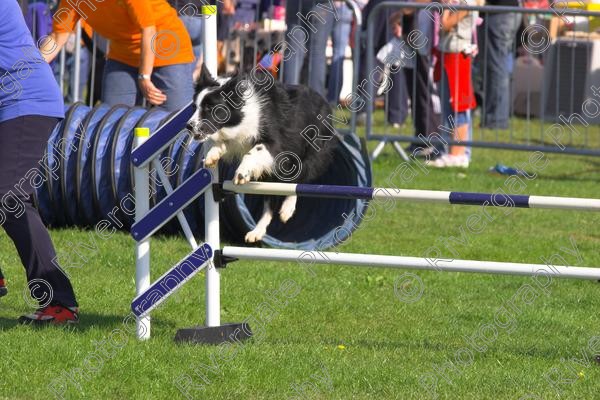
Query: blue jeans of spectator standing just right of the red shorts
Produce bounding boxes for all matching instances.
[479,13,521,129]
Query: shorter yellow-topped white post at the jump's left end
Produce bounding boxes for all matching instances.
[133,128,150,340]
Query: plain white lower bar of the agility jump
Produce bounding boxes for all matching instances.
[223,246,600,280]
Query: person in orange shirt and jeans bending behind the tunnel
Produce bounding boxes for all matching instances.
[40,0,194,111]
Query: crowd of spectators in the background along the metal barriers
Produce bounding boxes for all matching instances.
[19,0,600,167]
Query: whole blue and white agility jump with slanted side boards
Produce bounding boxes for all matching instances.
[131,103,600,343]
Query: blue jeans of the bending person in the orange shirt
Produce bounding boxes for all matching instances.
[102,59,194,111]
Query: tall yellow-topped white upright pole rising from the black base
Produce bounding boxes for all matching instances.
[202,6,221,326]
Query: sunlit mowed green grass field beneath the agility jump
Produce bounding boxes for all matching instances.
[0,113,600,400]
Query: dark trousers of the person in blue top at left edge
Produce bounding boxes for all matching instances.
[0,115,77,307]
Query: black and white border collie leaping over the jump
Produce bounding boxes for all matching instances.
[187,68,339,243]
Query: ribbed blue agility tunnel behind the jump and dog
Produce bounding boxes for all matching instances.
[35,103,372,249]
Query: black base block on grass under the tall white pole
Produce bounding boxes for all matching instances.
[175,323,252,344]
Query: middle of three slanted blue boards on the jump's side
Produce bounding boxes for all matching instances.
[131,168,212,242]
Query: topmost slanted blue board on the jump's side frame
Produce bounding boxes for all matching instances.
[131,102,196,168]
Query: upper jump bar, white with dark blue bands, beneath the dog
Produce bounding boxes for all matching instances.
[223,181,600,211]
